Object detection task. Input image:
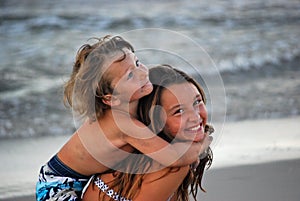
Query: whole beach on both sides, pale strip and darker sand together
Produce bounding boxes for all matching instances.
[0,117,300,201]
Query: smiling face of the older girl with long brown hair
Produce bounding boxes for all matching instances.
[161,82,207,142]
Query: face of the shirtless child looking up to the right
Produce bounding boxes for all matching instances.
[109,49,153,102]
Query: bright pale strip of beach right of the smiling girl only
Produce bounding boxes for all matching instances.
[211,116,300,168]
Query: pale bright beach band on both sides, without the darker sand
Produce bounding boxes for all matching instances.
[0,116,300,200]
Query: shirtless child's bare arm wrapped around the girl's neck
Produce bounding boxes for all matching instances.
[117,116,211,167]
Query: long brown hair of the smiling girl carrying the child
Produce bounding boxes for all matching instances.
[94,65,213,201]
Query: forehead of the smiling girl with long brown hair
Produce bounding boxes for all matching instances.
[161,82,200,107]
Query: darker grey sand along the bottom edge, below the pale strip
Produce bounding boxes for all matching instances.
[1,158,300,201]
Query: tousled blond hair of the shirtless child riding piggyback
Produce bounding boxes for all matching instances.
[64,35,134,121]
